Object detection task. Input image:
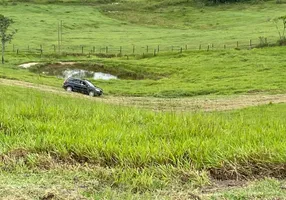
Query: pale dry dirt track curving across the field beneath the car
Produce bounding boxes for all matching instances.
[0,79,286,112]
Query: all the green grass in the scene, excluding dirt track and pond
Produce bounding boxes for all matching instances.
[0,0,286,199]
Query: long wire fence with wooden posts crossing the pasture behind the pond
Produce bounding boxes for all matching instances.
[3,37,275,57]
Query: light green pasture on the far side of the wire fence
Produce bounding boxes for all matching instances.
[0,1,286,54]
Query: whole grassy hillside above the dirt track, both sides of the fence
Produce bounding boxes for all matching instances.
[0,1,286,97]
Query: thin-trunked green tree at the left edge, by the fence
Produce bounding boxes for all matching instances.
[0,14,17,64]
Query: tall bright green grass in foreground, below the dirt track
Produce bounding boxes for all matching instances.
[0,86,286,177]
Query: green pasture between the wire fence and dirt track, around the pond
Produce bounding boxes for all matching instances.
[0,47,286,97]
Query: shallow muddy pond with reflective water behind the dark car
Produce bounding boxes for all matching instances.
[19,62,163,80]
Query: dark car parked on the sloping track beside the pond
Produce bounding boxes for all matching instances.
[63,78,103,96]
